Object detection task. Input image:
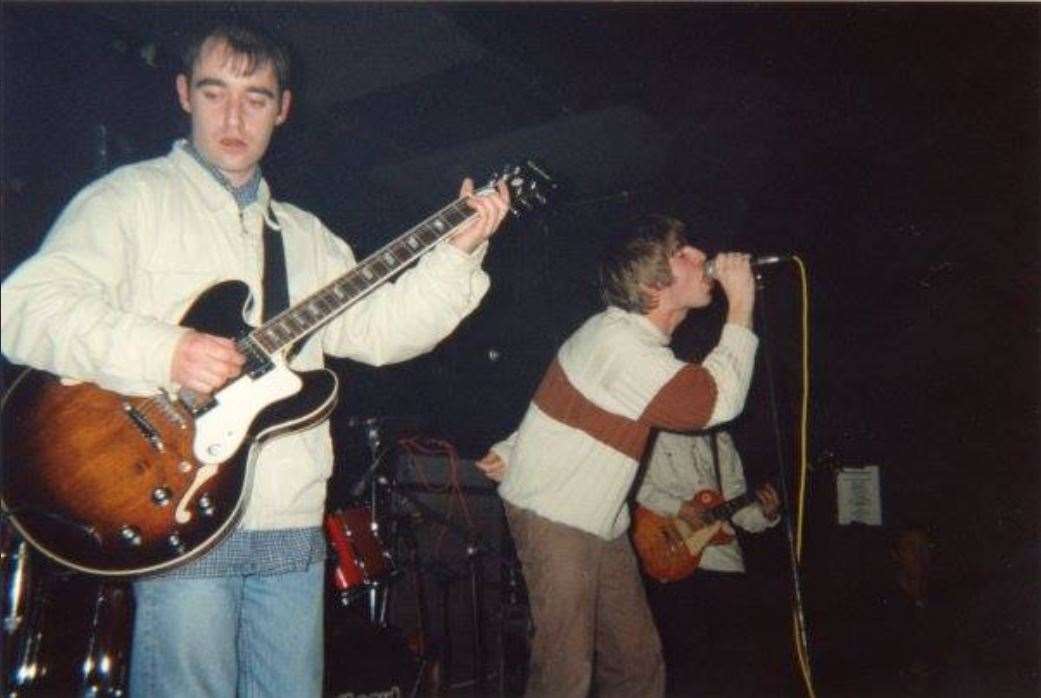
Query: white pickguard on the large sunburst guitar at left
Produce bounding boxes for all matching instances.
[194,358,304,464]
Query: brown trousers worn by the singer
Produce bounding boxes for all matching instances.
[503,501,665,698]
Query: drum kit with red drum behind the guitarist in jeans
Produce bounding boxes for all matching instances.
[0,423,528,698]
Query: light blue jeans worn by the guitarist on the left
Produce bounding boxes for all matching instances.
[130,563,325,698]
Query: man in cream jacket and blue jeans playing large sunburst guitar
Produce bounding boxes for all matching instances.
[0,17,510,698]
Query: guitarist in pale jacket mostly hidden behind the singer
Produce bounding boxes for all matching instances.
[634,431,781,696]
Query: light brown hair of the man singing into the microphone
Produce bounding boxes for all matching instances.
[600,213,687,314]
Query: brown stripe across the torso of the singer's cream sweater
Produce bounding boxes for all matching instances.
[534,359,651,461]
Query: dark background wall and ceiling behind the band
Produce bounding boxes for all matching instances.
[0,2,1041,696]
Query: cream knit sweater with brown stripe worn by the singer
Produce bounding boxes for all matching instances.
[492,307,759,540]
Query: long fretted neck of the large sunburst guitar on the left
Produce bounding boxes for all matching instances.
[248,197,480,356]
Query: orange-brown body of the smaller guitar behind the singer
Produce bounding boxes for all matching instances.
[632,490,734,583]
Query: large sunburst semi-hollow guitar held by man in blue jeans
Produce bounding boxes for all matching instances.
[0,161,553,575]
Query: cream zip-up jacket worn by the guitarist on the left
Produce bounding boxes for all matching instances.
[0,141,489,528]
